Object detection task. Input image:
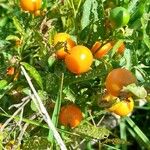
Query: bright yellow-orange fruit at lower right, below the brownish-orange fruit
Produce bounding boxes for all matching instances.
[108,97,134,116]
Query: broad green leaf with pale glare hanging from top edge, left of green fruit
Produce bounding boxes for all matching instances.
[78,0,106,45]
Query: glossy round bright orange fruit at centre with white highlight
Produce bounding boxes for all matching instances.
[65,45,93,74]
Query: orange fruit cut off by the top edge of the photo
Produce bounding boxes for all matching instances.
[20,0,42,12]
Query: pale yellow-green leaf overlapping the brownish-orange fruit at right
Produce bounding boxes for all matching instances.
[123,83,147,98]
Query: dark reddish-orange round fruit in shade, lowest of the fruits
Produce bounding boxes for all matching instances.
[59,104,83,128]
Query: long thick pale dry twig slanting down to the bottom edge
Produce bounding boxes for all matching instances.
[21,66,67,150]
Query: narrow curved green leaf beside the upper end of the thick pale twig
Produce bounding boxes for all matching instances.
[21,62,43,89]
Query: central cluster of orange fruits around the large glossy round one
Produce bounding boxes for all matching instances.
[54,33,125,74]
